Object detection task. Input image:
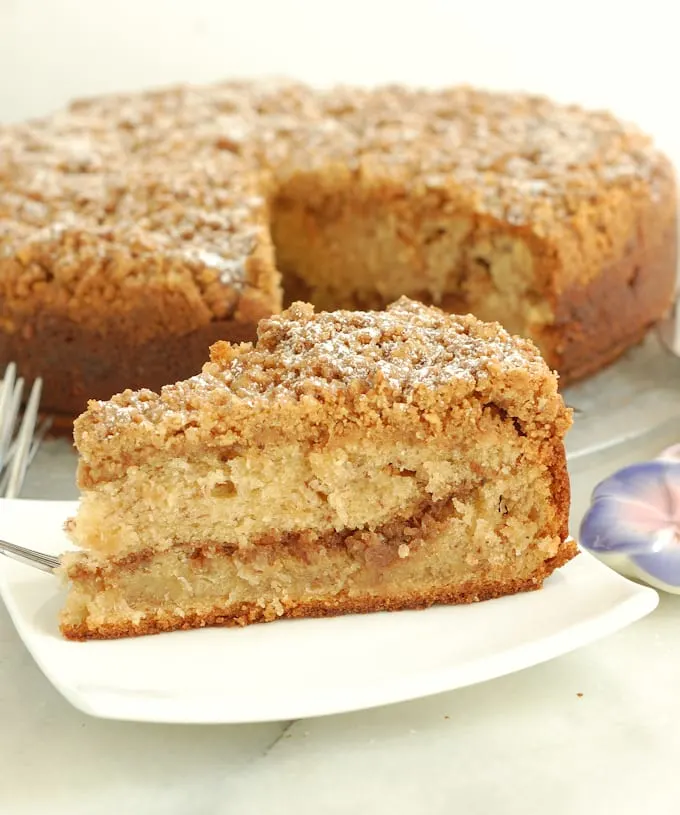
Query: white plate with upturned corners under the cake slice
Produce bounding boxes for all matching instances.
[0,500,658,723]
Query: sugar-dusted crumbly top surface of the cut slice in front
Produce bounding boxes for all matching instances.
[92,297,554,432]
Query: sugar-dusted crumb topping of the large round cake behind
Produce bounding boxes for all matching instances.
[0,81,666,317]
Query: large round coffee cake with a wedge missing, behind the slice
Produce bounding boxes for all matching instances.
[0,82,676,414]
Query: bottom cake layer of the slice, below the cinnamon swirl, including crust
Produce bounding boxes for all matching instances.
[61,498,577,639]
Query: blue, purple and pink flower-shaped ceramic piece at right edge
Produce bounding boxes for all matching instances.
[580,444,680,594]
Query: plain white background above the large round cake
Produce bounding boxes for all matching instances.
[0,0,680,159]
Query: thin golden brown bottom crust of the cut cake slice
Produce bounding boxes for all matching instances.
[61,540,578,640]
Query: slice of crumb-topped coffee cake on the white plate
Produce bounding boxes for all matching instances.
[61,299,576,639]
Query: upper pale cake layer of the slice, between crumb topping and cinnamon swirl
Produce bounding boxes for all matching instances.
[71,418,568,555]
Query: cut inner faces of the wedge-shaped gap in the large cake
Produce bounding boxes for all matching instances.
[271,180,554,339]
